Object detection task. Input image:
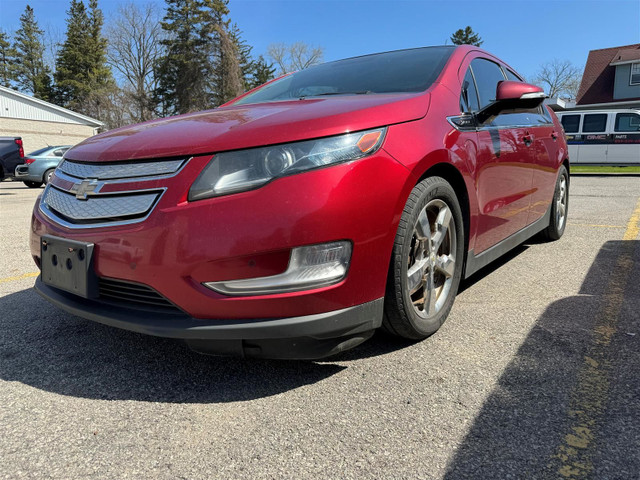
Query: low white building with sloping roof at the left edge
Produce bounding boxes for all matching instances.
[0,86,104,153]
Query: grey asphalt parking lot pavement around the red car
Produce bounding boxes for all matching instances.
[0,176,640,480]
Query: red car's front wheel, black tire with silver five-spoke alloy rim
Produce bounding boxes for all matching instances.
[383,177,465,340]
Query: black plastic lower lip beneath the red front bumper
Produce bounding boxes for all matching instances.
[35,277,383,359]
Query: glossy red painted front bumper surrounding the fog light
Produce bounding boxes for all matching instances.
[31,150,409,321]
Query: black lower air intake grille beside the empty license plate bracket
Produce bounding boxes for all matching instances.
[98,278,182,313]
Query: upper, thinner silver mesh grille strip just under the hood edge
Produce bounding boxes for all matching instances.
[58,159,185,180]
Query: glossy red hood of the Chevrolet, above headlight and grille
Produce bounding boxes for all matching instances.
[65,93,430,162]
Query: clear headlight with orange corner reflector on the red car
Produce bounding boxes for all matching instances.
[189,128,386,201]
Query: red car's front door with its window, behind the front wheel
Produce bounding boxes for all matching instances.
[471,58,533,255]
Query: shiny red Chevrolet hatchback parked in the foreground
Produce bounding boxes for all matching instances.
[31,46,569,359]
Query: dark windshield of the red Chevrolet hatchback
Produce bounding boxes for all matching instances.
[234,46,455,105]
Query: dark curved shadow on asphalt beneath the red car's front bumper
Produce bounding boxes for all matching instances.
[0,289,345,403]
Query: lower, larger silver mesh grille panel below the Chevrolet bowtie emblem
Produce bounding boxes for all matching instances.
[42,187,161,223]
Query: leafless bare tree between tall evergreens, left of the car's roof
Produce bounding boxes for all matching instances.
[106,2,163,122]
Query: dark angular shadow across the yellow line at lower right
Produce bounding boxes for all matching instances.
[444,241,640,480]
